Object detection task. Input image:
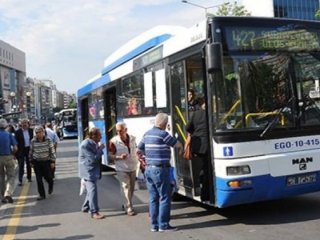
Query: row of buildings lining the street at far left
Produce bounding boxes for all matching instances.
[0,40,75,124]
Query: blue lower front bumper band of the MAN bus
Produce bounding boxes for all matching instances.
[216,172,320,208]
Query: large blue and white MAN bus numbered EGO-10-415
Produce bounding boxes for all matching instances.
[78,17,320,207]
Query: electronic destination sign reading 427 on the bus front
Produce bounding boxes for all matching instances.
[225,26,320,51]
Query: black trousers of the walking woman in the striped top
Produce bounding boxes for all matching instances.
[33,161,53,198]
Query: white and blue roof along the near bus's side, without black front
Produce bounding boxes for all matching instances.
[77,21,205,97]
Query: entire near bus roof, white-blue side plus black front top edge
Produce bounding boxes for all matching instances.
[77,16,319,97]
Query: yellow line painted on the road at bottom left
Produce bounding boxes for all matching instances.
[2,183,30,240]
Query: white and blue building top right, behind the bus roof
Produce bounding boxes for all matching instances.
[241,0,319,20]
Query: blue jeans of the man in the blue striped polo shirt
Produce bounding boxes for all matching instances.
[145,166,171,229]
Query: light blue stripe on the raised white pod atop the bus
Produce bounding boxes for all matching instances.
[101,34,172,75]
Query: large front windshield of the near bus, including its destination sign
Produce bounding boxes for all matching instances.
[213,22,320,131]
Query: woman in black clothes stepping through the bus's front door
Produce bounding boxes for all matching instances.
[186,98,210,201]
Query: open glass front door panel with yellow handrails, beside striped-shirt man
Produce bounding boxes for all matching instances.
[170,61,194,197]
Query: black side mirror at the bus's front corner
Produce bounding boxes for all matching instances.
[206,43,223,73]
